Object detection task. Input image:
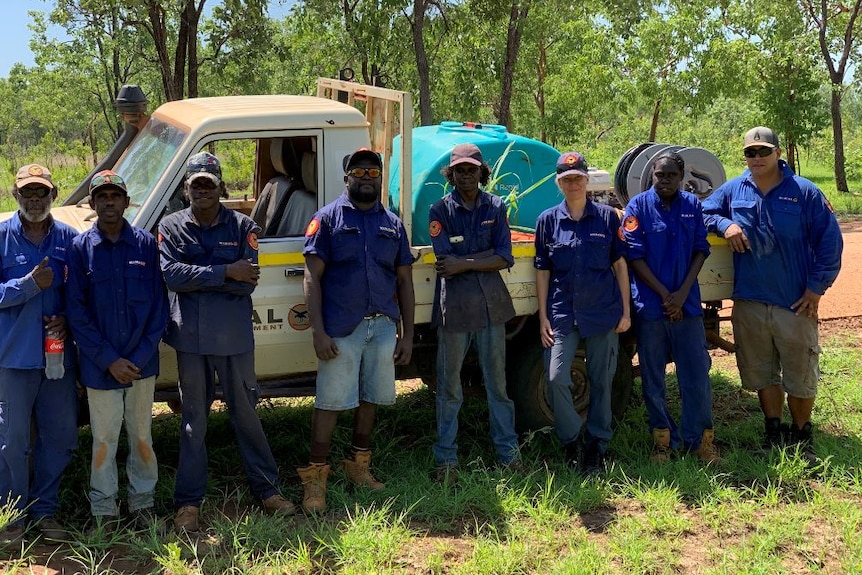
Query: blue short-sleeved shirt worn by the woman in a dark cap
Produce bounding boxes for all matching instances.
[533,200,625,337]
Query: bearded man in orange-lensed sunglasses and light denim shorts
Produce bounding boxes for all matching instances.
[297,148,414,513]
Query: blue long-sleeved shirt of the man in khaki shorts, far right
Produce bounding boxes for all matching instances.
[703,160,844,309]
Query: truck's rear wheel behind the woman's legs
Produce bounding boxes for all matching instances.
[509,343,634,431]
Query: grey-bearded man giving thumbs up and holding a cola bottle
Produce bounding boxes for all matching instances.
[0,164,78,543]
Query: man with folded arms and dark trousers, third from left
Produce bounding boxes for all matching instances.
[159,152,295,532]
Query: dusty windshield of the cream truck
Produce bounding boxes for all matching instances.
[114,118,187,222]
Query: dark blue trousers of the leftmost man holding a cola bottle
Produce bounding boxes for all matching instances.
[0,368,78,520]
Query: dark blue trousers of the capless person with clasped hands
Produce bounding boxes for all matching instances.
[637,316,712,450]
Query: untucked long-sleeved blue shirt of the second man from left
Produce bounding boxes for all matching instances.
[68,222,168,389]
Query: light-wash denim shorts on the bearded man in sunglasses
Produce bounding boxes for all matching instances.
[314,315,395,411]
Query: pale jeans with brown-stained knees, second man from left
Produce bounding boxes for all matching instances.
[87,376,159,516]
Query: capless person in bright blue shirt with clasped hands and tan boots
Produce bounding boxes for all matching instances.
[623,153,719,463]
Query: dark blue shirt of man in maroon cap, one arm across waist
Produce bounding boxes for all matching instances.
[428,189,515,332]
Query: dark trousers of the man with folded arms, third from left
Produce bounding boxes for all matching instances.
[174,351,278,507]
